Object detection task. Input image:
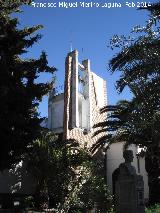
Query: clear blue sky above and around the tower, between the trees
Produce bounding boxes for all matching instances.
[18,0,153,116]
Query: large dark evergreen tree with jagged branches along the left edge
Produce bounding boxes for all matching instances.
[0,0,56,171]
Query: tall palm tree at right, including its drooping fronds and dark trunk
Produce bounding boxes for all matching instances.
[93,4,160,204]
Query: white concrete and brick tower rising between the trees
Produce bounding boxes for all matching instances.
[48,50,106,146]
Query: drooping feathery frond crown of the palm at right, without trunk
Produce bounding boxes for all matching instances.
[102,2,160,146]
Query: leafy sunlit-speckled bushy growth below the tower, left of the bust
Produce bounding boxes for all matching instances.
[26,130,111,213]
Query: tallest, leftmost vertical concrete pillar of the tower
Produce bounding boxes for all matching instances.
[63,50,79,140]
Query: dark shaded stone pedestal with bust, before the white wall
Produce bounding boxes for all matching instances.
[115,150,145,213]
